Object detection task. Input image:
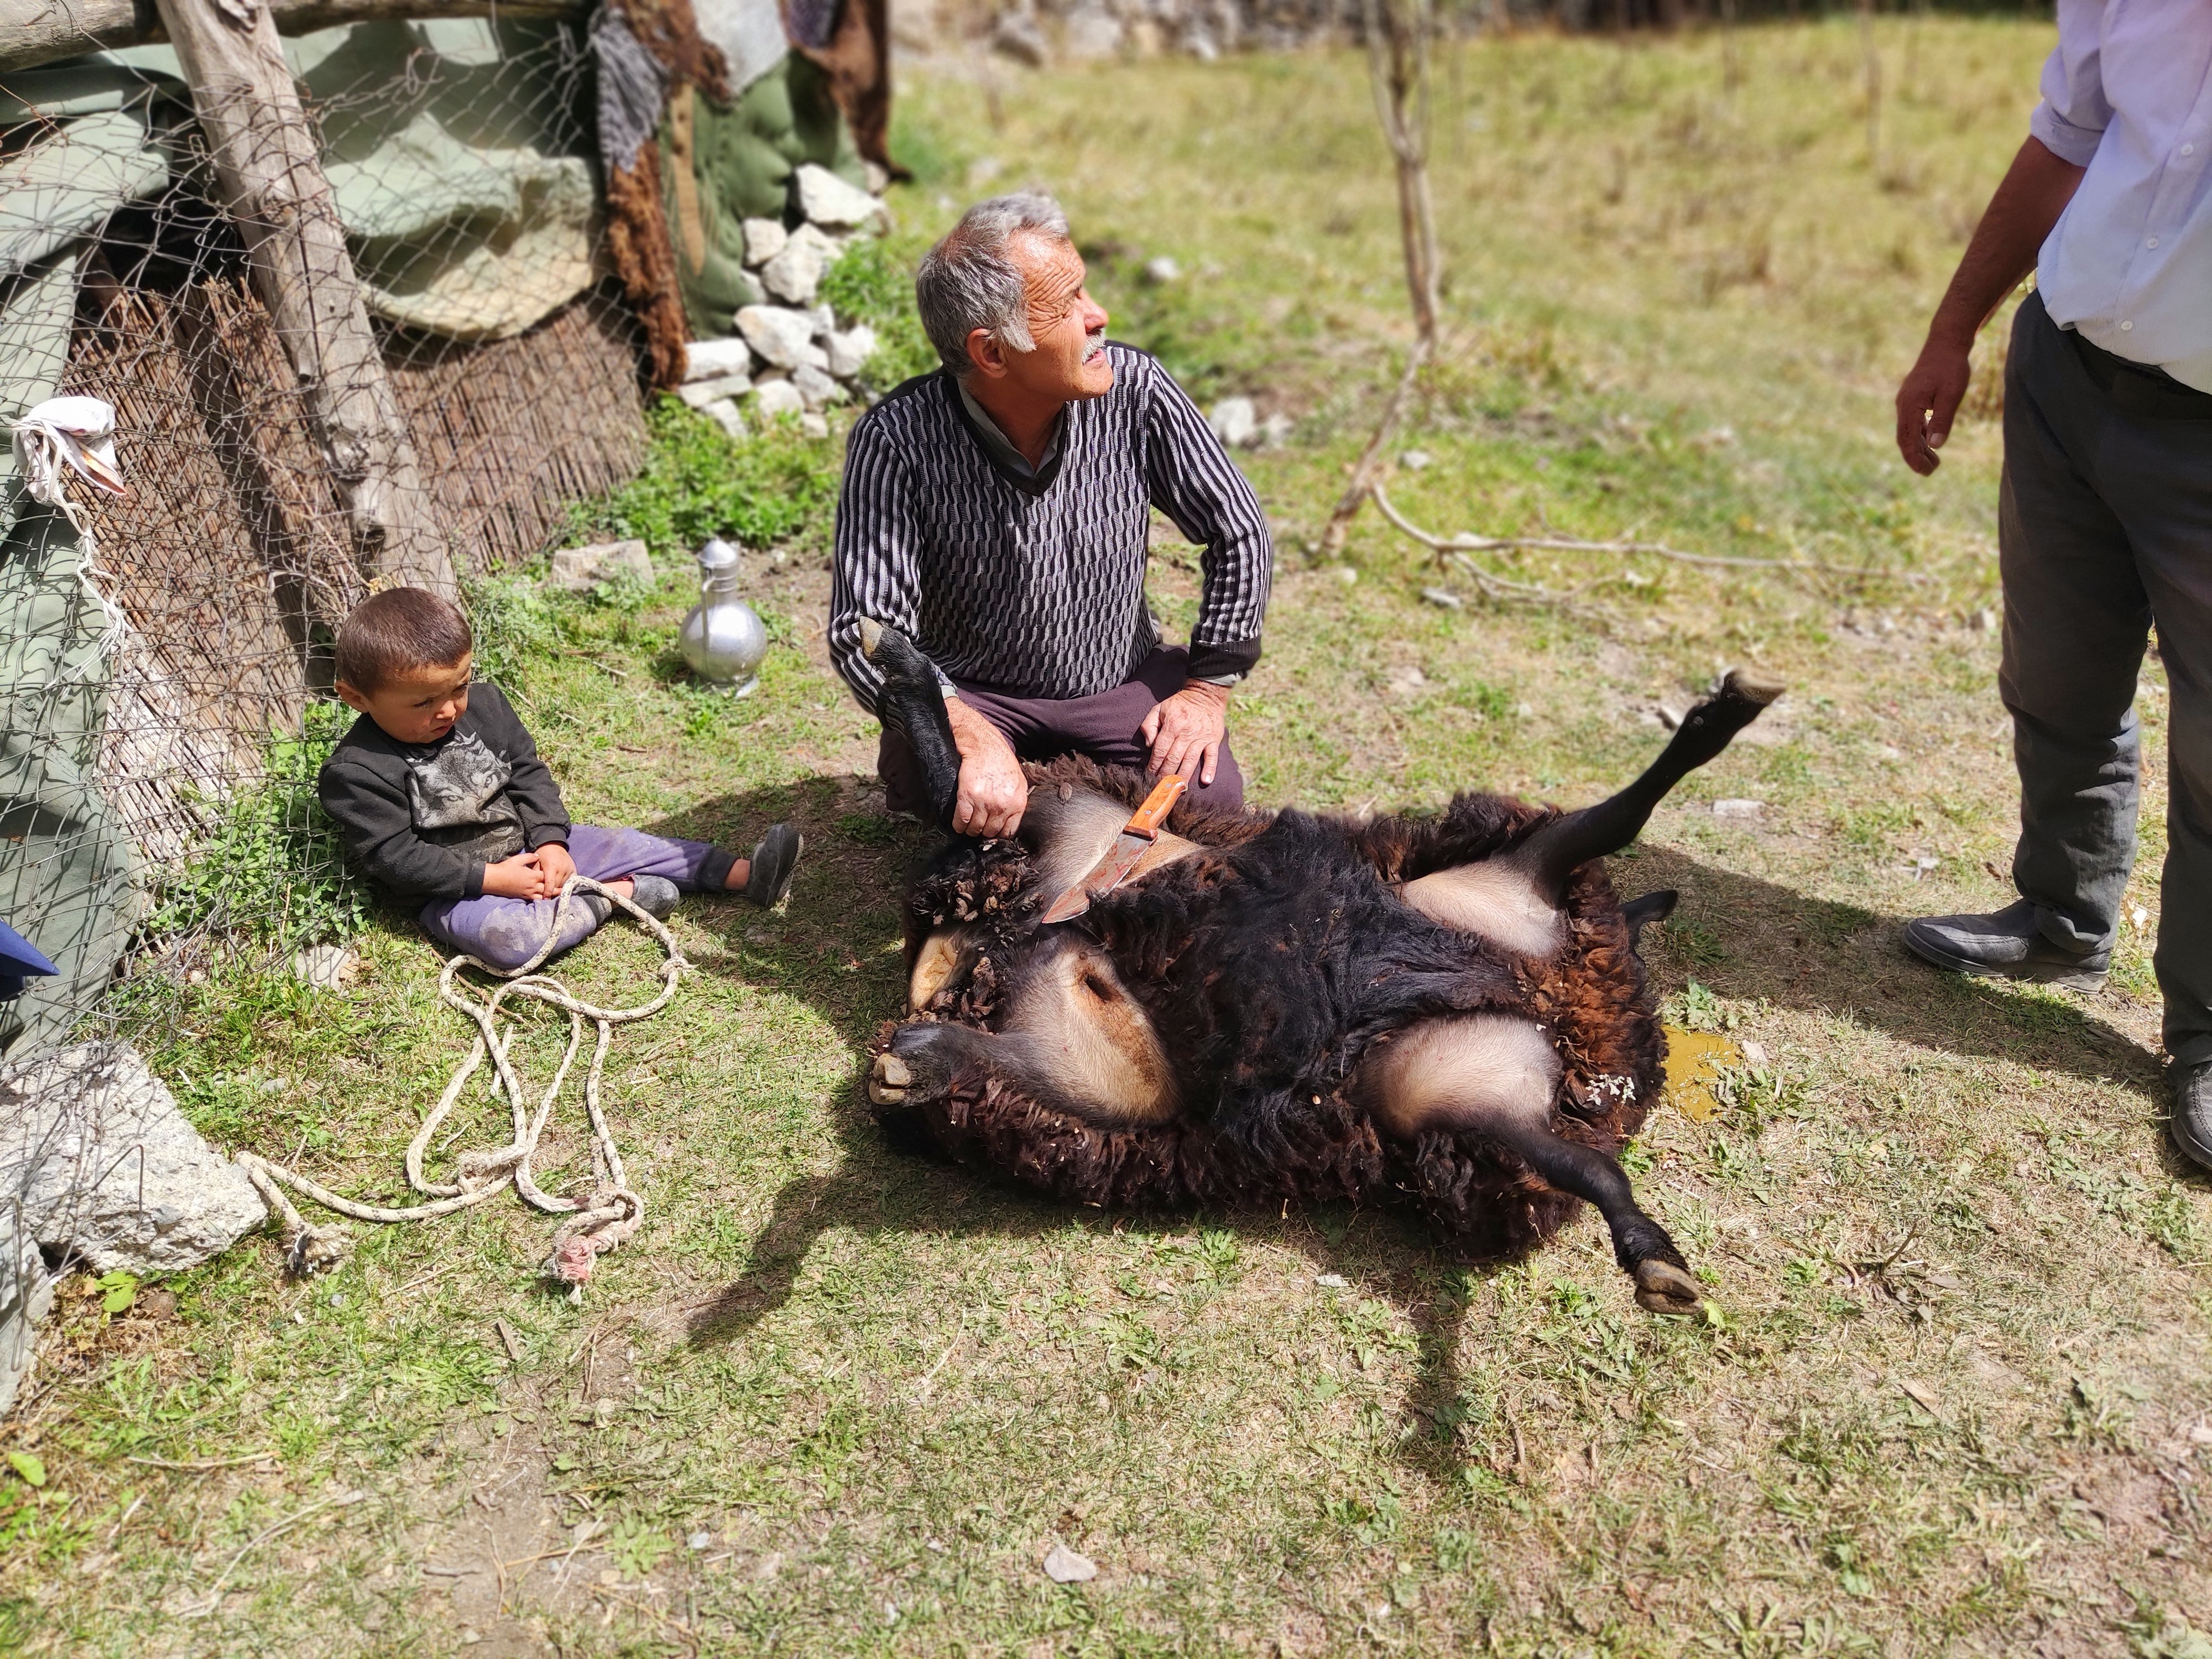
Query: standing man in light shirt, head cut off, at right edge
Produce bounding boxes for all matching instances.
[1898,0,2212,1168]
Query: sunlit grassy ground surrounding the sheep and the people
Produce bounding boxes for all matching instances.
[0,18,2212,1659]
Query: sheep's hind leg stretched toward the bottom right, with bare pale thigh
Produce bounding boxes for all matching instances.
[1356,1013,1699,1314]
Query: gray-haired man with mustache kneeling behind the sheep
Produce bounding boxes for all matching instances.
[830,195,1274,836]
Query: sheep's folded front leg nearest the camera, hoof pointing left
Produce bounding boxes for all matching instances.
[867,942,1181,1128]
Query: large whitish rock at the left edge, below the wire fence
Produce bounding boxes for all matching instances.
[0,1042,268,1274]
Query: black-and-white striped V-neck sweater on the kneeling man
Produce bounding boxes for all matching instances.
[830,343,1274,710]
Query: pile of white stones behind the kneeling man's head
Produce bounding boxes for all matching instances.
[677,164,885,438]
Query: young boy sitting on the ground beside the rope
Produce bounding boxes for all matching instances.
[316,588,803,969]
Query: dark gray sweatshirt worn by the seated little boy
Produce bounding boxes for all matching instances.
[316,681,568,898]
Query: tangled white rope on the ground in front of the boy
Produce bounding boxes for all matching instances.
[239,876,690,1301]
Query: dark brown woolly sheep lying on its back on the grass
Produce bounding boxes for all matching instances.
[863,624,1781,1314]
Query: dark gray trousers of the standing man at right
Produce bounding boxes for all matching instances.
[1997,294,2212,1064]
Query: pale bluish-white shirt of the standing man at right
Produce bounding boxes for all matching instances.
[2028,0,2212,392]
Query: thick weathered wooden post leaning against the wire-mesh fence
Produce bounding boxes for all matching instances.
[155,0,460,599]
